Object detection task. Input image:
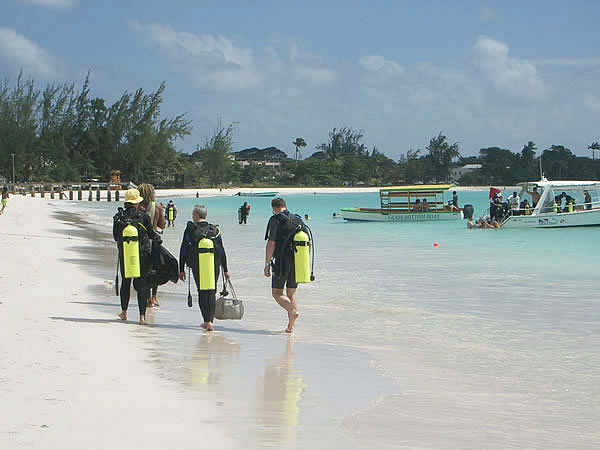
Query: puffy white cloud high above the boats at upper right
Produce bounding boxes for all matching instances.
[473,37,546,99]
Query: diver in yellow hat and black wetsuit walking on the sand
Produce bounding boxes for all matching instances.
[113,189,162,325]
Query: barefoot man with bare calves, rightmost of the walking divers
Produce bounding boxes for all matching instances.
[264,197,310,333]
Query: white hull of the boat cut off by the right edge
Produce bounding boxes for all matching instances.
[502,209,600,228]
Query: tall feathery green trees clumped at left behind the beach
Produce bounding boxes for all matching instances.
[0,73,192,182]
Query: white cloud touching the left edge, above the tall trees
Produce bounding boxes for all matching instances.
[0,27,58,78]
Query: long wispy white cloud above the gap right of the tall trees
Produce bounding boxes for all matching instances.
[129,21,262,90]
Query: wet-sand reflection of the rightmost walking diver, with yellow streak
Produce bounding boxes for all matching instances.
[256,336,306,448]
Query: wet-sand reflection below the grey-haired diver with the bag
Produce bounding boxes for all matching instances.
[190,333,240,389]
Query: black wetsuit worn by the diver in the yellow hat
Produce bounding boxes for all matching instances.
[113,207,162,316]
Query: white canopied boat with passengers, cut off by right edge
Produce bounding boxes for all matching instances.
[501,178,600,228]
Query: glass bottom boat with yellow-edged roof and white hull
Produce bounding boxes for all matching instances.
[342,184,462,222]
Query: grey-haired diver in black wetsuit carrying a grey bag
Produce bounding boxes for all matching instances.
[179,205,229,331]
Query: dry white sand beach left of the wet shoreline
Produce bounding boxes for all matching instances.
[0,195,230,449]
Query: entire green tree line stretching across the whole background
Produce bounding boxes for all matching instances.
[0,73,600,186]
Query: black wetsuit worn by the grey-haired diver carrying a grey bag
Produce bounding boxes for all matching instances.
[179,221,229,322]
